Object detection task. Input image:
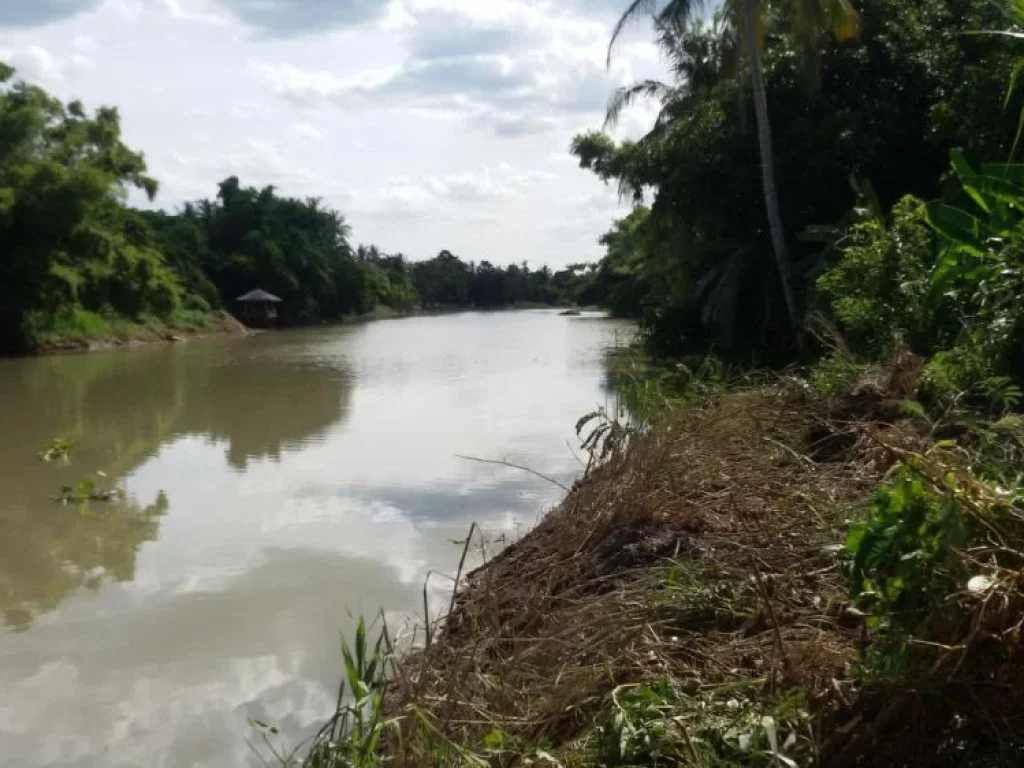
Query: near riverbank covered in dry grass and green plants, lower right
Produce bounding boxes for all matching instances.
[311,367,1024,766]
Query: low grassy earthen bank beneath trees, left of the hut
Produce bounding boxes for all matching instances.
[31,310,250,354]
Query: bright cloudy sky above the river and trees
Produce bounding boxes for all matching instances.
[0,0,664,268]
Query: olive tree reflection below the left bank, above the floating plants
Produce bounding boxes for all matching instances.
[0,340,350,475]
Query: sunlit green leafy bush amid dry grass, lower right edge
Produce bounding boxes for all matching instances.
[846,444,1024,675]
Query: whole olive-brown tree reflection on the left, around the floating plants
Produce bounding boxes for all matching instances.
[0,339,349,629]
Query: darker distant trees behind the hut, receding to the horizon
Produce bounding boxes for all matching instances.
[138,177,587,325]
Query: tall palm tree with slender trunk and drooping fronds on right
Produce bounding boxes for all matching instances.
[608,0,859,351]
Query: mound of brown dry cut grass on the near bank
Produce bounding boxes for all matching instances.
[374,388,905,764]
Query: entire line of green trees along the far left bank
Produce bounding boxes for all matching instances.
[0,63,586,351]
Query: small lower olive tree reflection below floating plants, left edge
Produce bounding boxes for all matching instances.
[0,492,168,631]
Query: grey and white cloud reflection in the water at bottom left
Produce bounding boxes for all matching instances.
[0,550,417,768]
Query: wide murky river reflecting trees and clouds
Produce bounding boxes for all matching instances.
[0,310,631,768]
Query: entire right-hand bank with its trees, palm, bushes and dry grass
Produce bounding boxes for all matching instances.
[288,0,1024,767]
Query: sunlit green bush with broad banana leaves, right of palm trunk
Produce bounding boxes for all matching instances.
[817,151,1024,404]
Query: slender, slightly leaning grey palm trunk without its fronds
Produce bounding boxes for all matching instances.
[742,0,804,354]
